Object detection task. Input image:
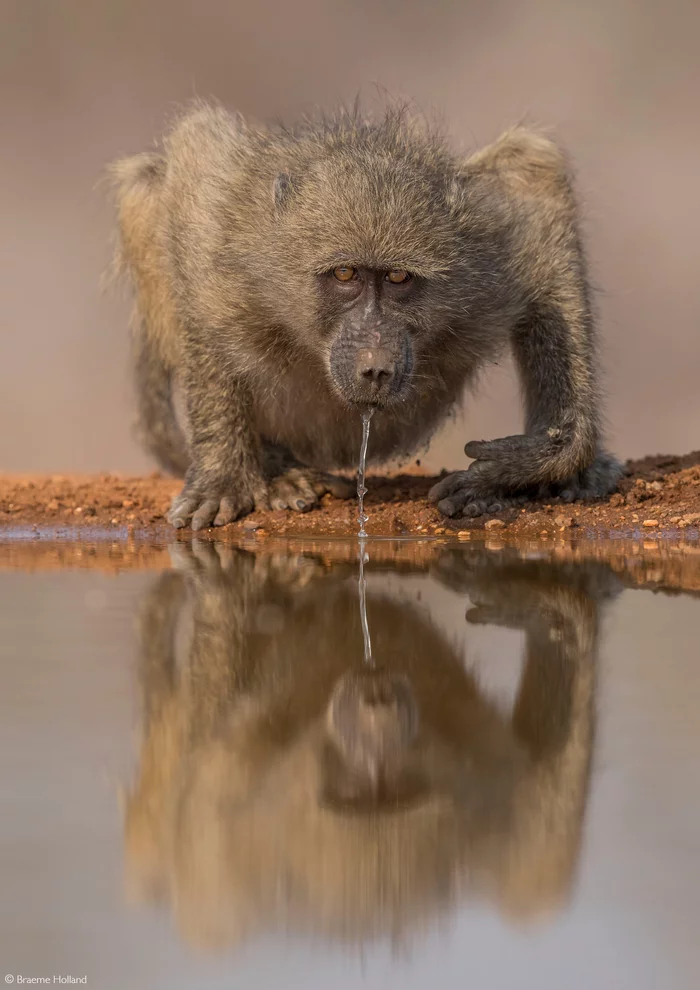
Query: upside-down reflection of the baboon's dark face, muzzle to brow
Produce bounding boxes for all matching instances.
[321,671,422,809]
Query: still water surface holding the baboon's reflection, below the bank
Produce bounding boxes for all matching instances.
[0,536,700,990]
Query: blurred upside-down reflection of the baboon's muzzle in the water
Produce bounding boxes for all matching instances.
[328,671,418,791]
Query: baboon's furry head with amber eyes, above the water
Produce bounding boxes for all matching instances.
[273,120,468,407]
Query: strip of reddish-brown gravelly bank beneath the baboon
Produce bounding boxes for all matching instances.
[0,452,700,540]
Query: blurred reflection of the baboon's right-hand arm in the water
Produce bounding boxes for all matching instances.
[501,585,597,915]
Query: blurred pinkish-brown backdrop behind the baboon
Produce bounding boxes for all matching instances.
[0,0,700,473]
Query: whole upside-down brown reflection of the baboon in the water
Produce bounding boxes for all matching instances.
[125,543,616,948]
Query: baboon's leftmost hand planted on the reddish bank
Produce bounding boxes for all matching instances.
[167,475,267,530]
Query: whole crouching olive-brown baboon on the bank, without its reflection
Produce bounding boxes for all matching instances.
[113,105,620,529]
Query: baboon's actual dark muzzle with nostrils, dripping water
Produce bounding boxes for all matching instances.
[330,331,413,406]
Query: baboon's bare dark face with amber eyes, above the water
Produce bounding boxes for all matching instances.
[319,262,420,406]
